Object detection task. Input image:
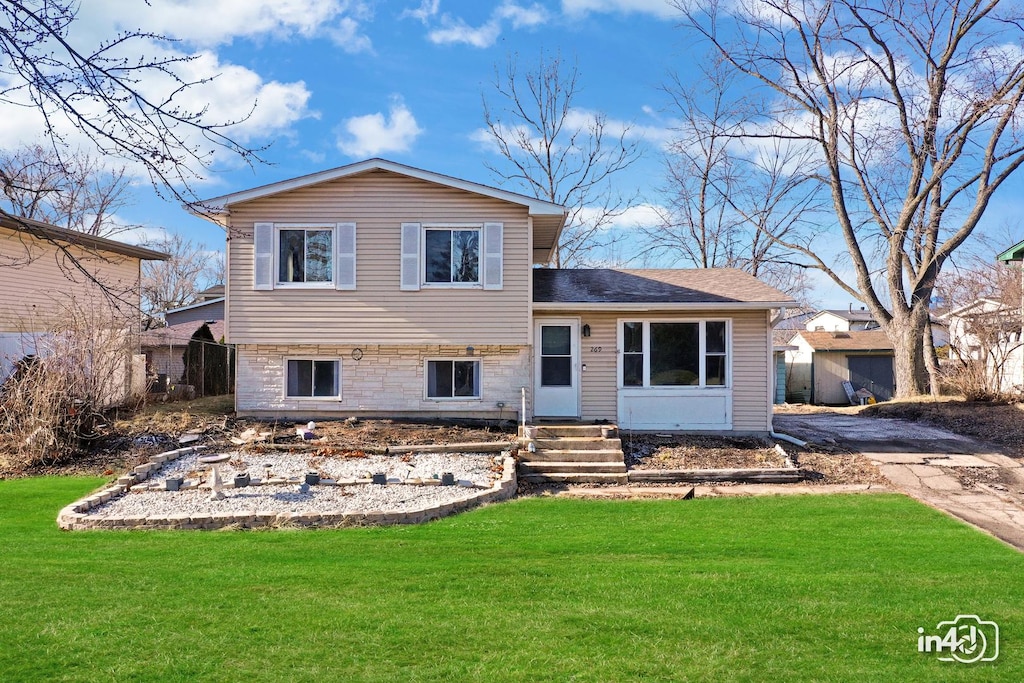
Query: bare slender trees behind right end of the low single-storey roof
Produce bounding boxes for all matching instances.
[640,61,821,296]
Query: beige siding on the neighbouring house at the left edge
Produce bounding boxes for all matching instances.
[0,228,139,332]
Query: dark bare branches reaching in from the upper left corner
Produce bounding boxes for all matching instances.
[0,0,261,298]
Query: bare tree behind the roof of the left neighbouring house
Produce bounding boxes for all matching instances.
[0,144,137,237]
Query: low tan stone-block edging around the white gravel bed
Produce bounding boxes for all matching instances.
[57,446,518,530]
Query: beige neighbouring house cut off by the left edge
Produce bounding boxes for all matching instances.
[0,216,169,404]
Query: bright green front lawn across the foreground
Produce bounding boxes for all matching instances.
[0,478,1024,681]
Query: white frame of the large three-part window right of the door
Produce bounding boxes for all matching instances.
[615,316,733,392]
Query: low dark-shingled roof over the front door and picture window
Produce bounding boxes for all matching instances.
[534,268,797,310]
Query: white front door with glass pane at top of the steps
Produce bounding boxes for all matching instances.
[534,318,580,418]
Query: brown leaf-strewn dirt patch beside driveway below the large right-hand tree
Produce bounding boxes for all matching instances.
[861,398,1024,458]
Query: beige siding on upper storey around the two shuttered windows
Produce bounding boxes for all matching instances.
[227,171,530,346]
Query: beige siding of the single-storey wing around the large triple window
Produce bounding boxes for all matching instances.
[536,308,771,433]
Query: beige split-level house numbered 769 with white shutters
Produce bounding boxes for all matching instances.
[189,159,795,433]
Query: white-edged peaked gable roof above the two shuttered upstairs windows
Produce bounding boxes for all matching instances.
[185,159,568,259]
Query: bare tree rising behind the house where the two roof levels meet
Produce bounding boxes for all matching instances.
[483,54,640,268]
